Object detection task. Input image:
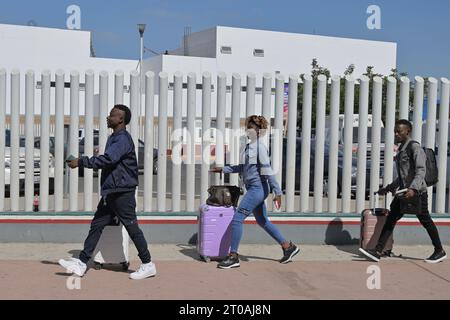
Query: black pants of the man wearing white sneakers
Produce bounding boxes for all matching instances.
[80,191,151,263]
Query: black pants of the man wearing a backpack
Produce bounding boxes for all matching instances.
[376,193,442,252]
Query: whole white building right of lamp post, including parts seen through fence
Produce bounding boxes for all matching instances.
[144,26,397,117]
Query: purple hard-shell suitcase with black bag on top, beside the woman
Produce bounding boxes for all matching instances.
[197,204,235,262]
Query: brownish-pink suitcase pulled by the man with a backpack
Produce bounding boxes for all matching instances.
[360,195,394,256]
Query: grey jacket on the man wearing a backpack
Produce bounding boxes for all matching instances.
[386,139,427,193]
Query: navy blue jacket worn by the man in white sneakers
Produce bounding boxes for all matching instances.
[78,129,139,196]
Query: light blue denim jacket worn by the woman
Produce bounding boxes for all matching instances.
[223,140,283,195]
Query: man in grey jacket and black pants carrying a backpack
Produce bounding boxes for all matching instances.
[359,120,447,263]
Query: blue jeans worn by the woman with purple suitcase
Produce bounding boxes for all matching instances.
[230,181,286,253]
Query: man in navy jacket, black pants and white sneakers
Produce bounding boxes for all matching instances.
[59,105,156,280]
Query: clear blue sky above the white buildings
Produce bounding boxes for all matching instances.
[0,0,450,78]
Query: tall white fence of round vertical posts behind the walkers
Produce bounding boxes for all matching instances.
[0,70,450,213]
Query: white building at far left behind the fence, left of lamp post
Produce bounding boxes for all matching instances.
[0,24,138,115]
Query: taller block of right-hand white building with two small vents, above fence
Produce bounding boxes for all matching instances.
[166,26,397,83]
